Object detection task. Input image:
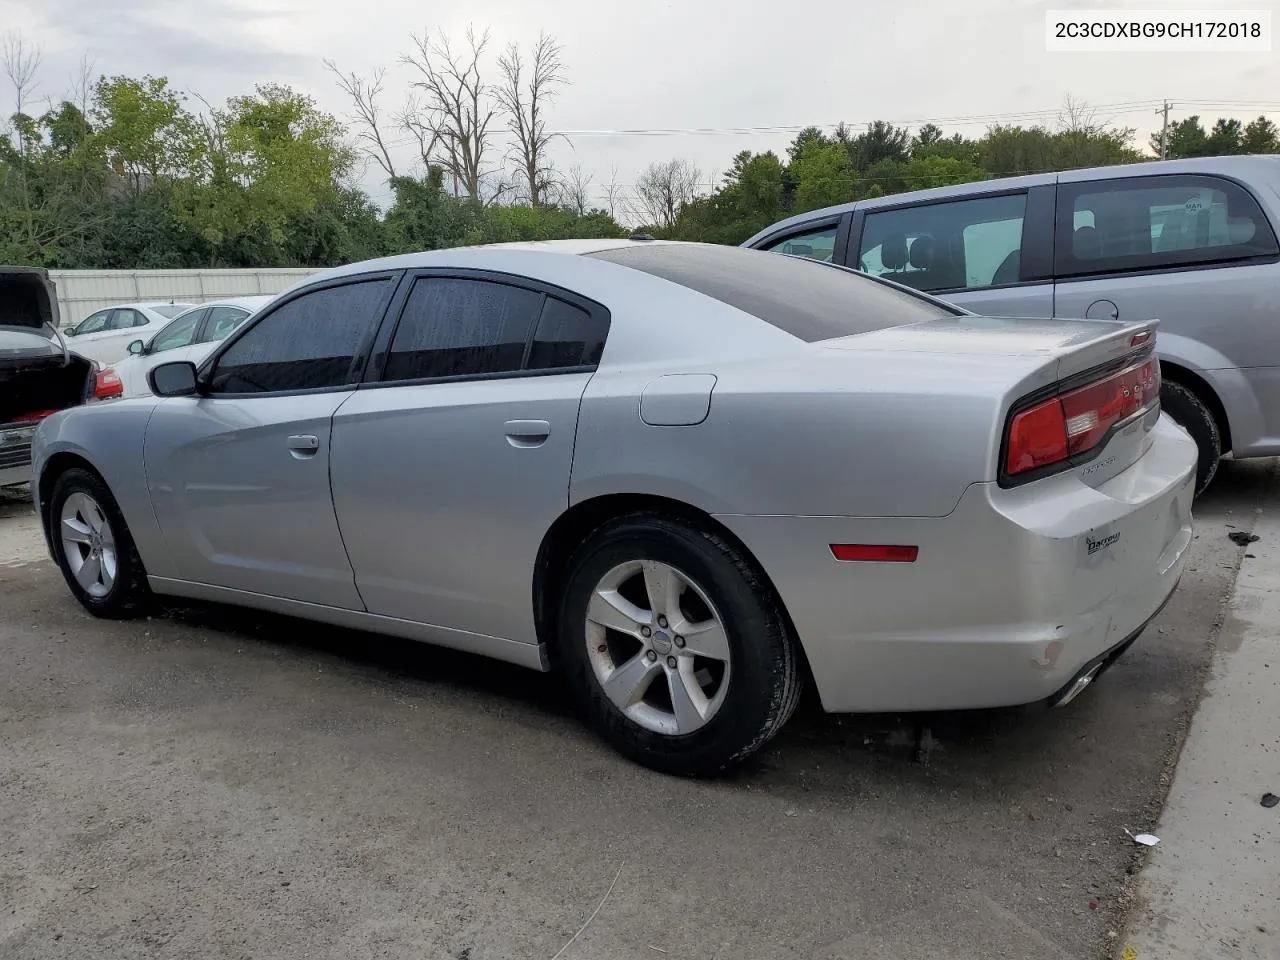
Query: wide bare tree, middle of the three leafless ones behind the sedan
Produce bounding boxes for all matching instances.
[403,27,500,200]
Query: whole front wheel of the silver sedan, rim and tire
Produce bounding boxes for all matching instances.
[49,467,150,620]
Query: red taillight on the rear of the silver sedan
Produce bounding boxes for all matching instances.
[1005,357,1160,476]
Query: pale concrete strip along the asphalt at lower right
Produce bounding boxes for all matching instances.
[1120,471,1280,960]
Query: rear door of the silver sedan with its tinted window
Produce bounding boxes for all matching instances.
[332,271,608,643]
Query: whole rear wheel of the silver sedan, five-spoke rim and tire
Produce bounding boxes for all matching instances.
[558,513,803,777]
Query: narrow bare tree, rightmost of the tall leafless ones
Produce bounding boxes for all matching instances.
[495,33,566,206]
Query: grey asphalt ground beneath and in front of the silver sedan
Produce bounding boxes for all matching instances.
[0,463,1276,960]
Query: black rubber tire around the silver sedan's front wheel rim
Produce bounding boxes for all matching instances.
[49,467,151,620]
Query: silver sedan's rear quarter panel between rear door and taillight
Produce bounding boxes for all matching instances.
[571,348,1051,517]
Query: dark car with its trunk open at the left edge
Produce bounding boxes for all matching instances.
[0,266,97,488]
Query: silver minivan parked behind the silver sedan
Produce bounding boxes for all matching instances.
[742,156,1280,493]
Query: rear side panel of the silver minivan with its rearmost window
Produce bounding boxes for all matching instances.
[1055,173,1280,448]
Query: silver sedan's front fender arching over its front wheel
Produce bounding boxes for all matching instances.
[32,397,172,576]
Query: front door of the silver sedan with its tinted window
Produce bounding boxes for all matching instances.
[145,278,394,609]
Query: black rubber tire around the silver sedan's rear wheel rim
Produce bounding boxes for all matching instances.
[557,512,804,777]
